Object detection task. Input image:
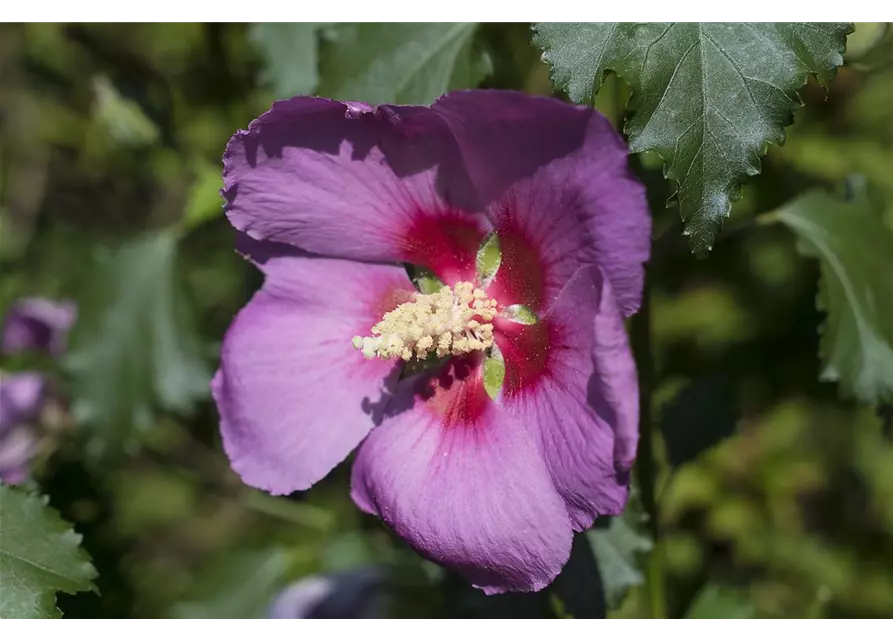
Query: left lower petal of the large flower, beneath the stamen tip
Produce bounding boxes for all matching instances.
[211,238,411,494]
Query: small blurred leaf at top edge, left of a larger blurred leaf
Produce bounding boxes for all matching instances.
[248,18,333,99]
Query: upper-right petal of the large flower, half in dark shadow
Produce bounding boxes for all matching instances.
[432,91,651,316]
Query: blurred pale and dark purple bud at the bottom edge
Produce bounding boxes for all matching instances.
[267,566,388,624]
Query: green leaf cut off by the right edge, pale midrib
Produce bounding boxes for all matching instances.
[773,178,893,404]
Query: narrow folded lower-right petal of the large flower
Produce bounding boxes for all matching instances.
[497,266,639,531]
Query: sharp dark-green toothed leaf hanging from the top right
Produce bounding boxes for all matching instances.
[535,22,852,256]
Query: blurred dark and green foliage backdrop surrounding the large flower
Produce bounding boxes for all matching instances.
[0,18,893,621]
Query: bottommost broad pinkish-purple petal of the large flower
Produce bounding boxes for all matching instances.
[351,358,572,594]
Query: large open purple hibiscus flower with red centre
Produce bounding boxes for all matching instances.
[212,91,650,594]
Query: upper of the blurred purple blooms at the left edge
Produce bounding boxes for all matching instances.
[0,298,77,356]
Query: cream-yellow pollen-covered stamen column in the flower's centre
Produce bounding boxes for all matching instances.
[353,282,496,361]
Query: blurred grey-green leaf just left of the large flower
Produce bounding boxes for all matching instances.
[66,231,210,458]
